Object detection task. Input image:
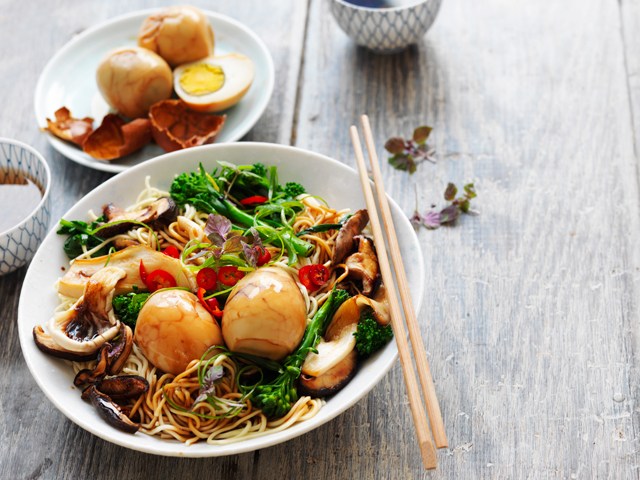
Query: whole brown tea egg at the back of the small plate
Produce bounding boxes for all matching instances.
[138,5,214,67]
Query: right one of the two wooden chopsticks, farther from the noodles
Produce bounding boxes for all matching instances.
[360,115,449,448]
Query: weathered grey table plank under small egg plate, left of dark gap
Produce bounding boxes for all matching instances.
[0,0,307,479]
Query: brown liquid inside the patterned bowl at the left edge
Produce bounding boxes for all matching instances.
[0,172,42,233]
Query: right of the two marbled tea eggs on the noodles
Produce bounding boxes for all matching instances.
[222,267,307,361]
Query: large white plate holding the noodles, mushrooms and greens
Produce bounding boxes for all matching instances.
[18,142,424,457]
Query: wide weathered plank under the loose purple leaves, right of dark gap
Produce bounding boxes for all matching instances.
[288,0,640,478]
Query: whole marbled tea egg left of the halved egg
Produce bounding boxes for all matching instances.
[96,47,173,118]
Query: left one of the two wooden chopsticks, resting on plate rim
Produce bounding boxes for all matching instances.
[349,126,438,470]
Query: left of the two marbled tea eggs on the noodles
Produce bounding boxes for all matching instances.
[134,290,224,375]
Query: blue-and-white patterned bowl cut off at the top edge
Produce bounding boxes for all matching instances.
[331,0,442,53]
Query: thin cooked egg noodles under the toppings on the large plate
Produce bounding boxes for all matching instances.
[58,177,356,445]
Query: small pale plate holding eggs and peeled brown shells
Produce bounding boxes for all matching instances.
[34,9,275,172]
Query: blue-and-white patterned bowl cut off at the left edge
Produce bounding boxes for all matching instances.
[0,138,51,275]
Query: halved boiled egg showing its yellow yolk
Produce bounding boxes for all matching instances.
[173,53,254,112]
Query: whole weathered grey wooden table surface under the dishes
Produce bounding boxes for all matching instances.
[0,0,640,480]
